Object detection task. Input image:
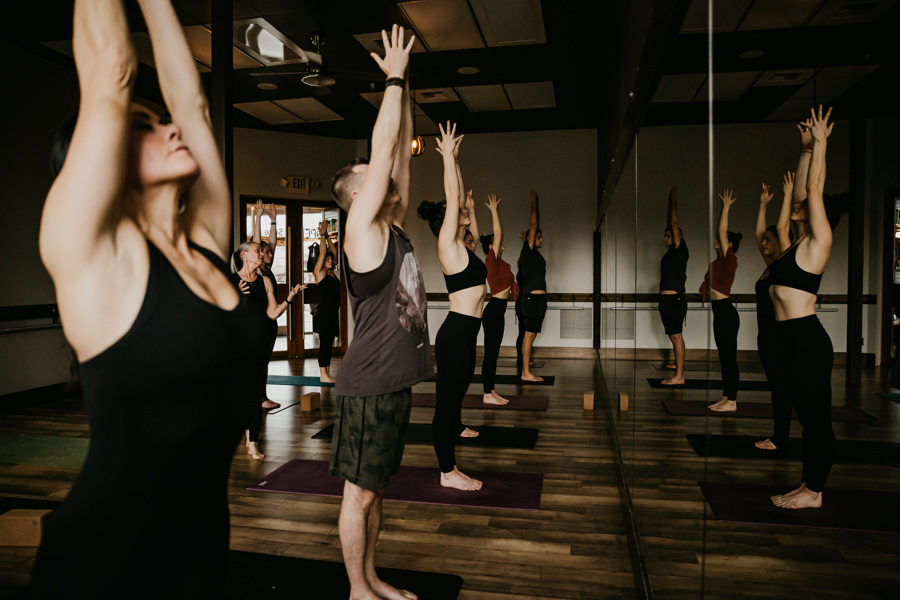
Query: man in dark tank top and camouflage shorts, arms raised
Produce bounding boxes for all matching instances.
[329,25,434,600]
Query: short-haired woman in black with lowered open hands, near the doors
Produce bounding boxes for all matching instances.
[231,242,306,460]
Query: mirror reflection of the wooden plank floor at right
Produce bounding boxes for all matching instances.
[603,360,900,598]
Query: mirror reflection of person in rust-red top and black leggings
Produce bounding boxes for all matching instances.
[700,188,743,412]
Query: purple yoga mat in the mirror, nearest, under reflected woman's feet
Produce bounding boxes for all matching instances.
[699,481,900,533]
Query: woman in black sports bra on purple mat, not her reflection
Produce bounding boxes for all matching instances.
[418,122,487,491]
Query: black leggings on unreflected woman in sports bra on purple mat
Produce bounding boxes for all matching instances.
[431,312,481,473]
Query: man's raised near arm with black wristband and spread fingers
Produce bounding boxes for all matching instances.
[344,25,415,273]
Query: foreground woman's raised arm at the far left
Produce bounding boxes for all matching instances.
[39,0,137,278]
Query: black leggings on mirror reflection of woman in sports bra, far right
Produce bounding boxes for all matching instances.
[775,315,834,493]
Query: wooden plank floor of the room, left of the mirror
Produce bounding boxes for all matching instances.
[0,358,636,600]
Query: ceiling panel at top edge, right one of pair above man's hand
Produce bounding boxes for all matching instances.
[470,0,552,46]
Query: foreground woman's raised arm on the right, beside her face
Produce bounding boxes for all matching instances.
[138,0,232,257]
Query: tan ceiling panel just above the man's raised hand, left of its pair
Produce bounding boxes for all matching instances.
[397,0,484,52]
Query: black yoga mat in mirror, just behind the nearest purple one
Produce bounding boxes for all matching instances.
[687,433,900,467]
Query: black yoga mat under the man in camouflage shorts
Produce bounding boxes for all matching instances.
[225,550,463,600]
